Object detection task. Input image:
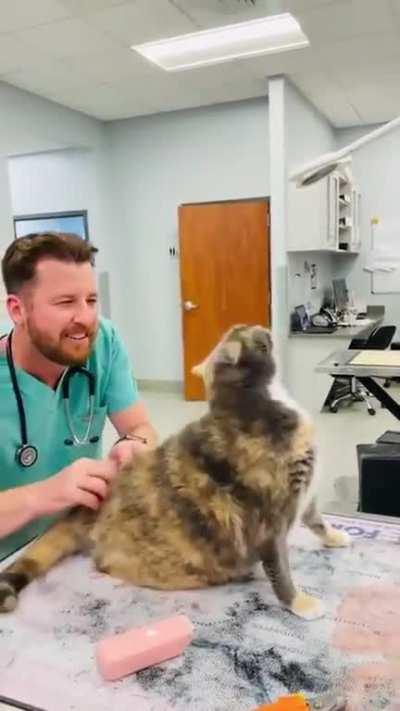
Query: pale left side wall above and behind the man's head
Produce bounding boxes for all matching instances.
[0,82,134,335]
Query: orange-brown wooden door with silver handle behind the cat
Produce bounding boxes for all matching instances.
[179,199,270,400]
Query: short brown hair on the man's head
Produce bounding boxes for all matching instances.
[1,232,98,294]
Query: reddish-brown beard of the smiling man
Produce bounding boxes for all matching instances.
[27,319,98,366]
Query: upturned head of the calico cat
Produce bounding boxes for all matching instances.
[192,325,276,398]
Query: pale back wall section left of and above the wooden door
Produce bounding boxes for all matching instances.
[108,99,269,380]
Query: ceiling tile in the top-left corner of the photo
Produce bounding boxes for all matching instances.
[0,0,70,33]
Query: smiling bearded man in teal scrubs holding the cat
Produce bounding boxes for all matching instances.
[0,233,156,560]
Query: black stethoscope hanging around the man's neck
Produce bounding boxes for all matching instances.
[6,331,100,467]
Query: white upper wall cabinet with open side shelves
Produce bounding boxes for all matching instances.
[287,173,361,254]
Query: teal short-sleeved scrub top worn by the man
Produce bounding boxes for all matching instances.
[0,319,138,560]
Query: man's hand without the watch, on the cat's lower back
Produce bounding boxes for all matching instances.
[32,458,117,516]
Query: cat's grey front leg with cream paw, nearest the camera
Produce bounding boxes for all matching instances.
[260,533,323,620]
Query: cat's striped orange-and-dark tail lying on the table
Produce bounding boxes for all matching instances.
[0,508,93,613]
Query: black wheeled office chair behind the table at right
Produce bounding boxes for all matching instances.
[329,326,396,415]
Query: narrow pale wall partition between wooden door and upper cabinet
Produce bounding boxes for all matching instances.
[269,77,334,410]
